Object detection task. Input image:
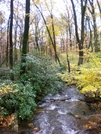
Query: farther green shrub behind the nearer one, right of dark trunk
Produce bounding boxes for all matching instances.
[20,55,62,100]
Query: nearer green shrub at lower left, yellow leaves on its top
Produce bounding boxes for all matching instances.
[0,82,36,120]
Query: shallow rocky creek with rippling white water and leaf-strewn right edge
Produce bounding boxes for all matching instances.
[0,86,101,134]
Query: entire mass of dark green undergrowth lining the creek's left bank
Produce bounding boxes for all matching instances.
[0,53,62,120]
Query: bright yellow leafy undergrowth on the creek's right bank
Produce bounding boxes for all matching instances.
[58,53,101,97]
